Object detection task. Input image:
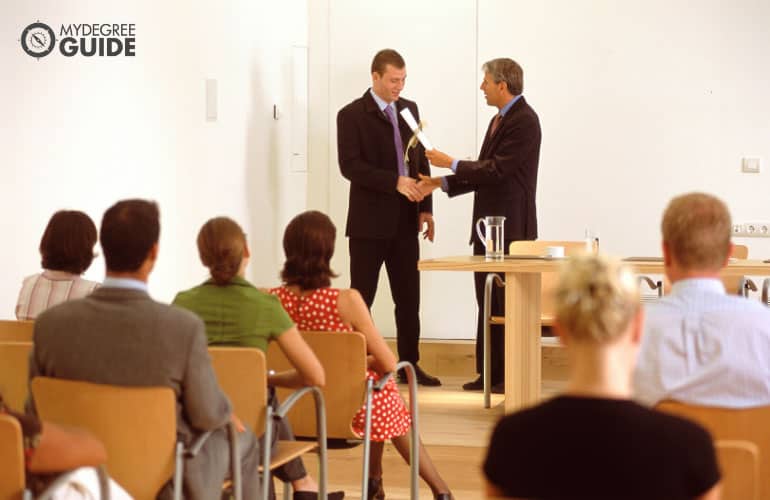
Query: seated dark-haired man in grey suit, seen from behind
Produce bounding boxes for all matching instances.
[30,200,259,499]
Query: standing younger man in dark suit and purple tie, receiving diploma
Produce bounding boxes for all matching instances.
[337,49,441,385]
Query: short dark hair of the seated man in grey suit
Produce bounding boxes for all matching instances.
[99,199,160,272]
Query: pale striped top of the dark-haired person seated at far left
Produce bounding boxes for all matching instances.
[16,269,99,320]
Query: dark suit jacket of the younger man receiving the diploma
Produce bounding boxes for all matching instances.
[337,90,433,239]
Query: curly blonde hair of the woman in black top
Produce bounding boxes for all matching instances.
[556,254,640,344]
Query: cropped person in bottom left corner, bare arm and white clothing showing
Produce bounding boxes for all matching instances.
[0,394,131,500]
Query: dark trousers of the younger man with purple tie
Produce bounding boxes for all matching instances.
[348,231,420,363]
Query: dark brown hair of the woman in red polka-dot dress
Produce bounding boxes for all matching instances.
[281,210,337,290]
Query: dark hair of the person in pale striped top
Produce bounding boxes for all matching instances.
[40,210,96,274]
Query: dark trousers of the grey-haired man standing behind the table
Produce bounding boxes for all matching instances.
[473,238,511,385]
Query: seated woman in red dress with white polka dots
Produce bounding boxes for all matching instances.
[271,211,452,500]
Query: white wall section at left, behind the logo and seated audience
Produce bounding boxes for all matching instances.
[0,0,307,318]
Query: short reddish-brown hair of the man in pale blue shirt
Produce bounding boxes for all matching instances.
[660,193,732,271]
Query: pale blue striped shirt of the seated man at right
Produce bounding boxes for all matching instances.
[634,278,770,408]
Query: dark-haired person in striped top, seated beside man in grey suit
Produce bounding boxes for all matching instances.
[16,210,99,320]
